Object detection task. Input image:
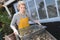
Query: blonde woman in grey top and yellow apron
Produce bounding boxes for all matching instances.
[10,1,39,39]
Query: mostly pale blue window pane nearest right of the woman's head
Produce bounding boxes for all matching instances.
[28,0,38,19]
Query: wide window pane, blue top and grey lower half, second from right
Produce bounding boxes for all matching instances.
[45,0,57,18]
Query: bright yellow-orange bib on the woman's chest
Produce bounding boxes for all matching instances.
[18,17,30,29]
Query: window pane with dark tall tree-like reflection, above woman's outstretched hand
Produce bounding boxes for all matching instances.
[35,0,47,19]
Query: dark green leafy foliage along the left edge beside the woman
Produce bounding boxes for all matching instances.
[0,8,12,40]
